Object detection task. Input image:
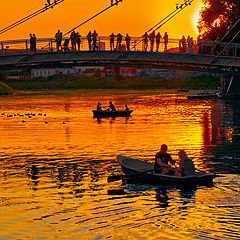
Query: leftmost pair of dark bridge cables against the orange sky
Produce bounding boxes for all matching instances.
[0,0,64,34]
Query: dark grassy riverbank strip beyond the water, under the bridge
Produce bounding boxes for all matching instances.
[0,75,219,94]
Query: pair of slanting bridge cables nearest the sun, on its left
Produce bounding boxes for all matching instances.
[132,0,194,48]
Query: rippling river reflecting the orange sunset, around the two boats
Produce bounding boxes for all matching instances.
[0,90,240,240]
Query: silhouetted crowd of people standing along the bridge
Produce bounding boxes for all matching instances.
[29,30,201,54]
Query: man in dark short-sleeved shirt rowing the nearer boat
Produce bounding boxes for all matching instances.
[154,144,183,176]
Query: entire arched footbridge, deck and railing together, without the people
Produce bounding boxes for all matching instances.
[0,37,240,75]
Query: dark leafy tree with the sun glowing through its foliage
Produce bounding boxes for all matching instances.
[197,0,240,42]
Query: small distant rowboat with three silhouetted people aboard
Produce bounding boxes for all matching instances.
[92,101,133,118]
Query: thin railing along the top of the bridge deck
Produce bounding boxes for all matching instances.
[0,36,240,57]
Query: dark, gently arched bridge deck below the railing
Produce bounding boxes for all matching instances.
[0,51,240,73]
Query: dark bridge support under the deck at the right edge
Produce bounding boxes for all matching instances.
[220,74,240,98]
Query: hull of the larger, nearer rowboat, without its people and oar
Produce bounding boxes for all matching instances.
[117,155,216,186]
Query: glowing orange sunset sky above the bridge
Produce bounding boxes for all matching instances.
[0,0,202,40]
